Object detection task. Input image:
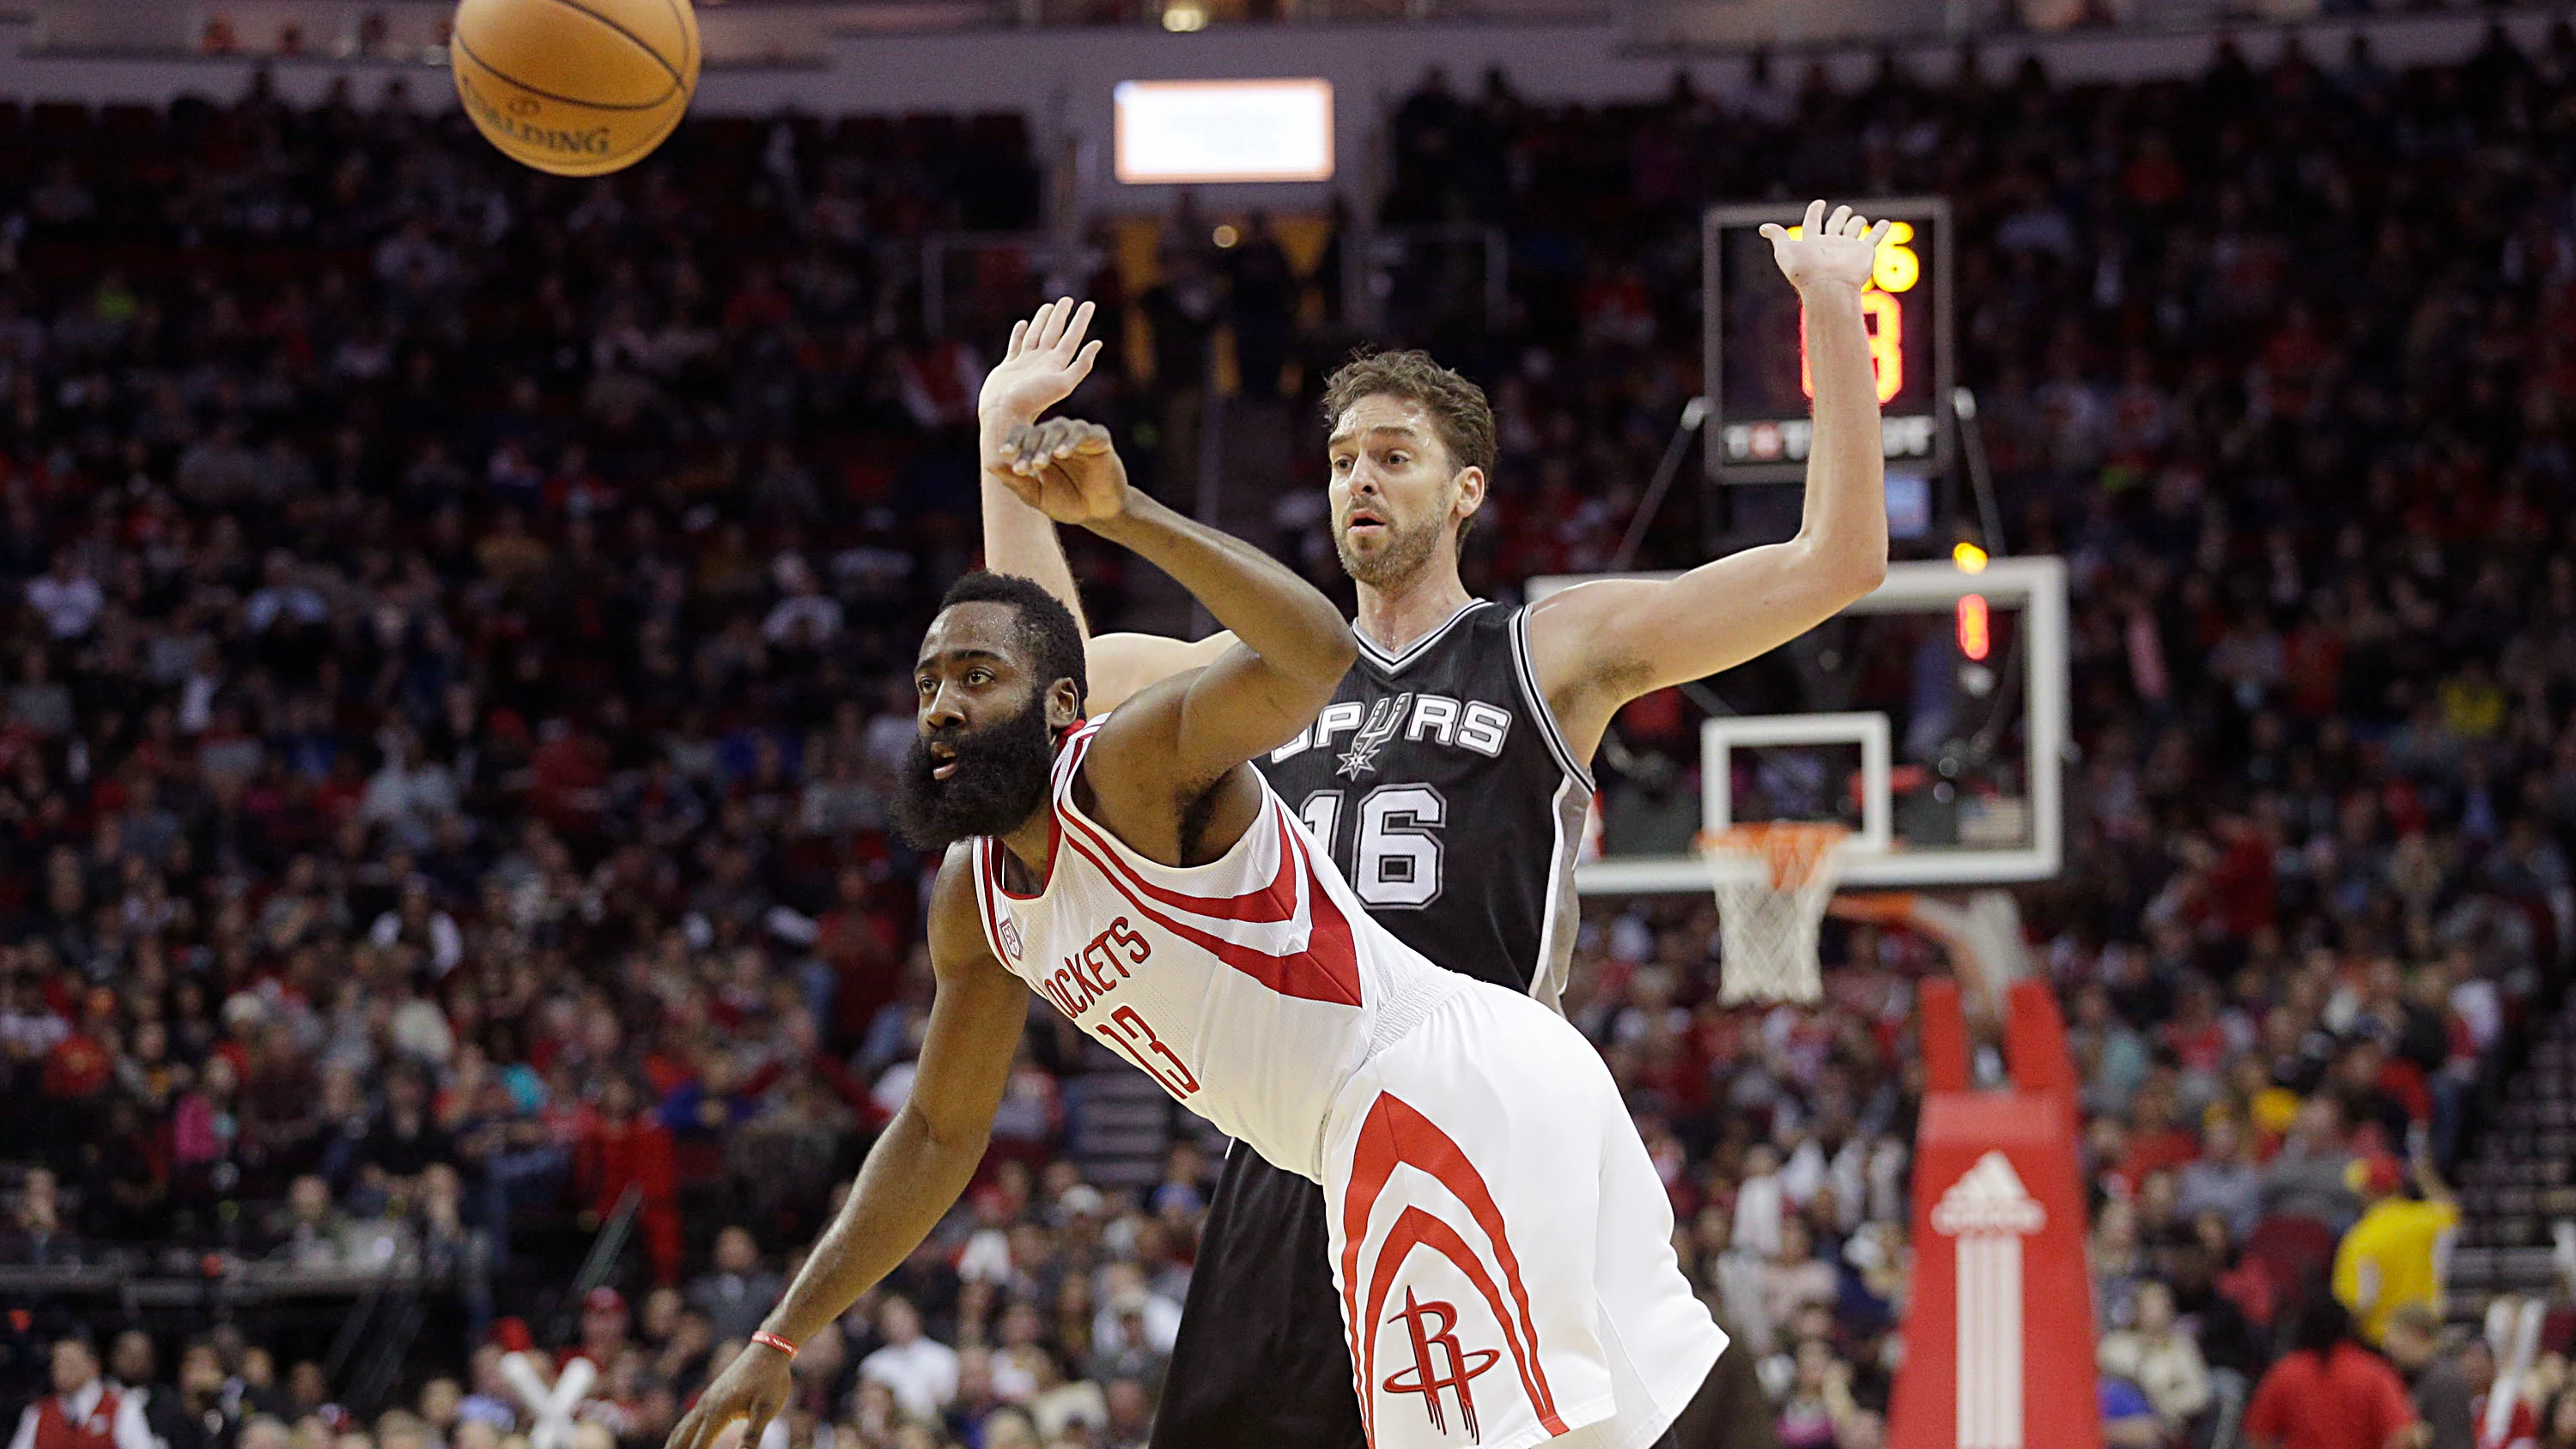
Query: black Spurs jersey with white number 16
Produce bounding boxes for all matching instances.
[1252,600,1592,1006]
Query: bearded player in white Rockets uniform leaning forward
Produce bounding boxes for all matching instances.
[670,420,1726,1449]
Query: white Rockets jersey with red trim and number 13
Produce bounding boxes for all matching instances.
[974,721,1463,1181]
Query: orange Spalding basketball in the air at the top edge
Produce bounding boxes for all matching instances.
[448,0,698,175]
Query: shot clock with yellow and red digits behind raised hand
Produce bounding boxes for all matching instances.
[1700,198,1950,484]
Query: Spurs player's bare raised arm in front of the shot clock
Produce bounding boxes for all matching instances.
[1530,201,1888,754]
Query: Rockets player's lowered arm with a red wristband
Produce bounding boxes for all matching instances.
[665,844,1028,1449]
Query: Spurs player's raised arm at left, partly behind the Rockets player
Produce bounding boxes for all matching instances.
[976,296,1234,716]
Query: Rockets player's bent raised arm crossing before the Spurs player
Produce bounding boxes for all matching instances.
[989,417,1360,792]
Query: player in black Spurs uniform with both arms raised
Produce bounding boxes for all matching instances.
[981,201,1888,1449]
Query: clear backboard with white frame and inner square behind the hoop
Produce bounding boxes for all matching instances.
[1528,559,2066,895]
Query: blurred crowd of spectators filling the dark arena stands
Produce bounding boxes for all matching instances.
[0,16,2576,1449]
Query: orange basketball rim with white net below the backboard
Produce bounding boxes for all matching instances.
[1698,821,1852,1006]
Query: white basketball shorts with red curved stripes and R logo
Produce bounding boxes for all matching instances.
[1324,983,1726,1449]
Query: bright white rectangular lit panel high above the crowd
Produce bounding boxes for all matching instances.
[1113,77,1332,185]
